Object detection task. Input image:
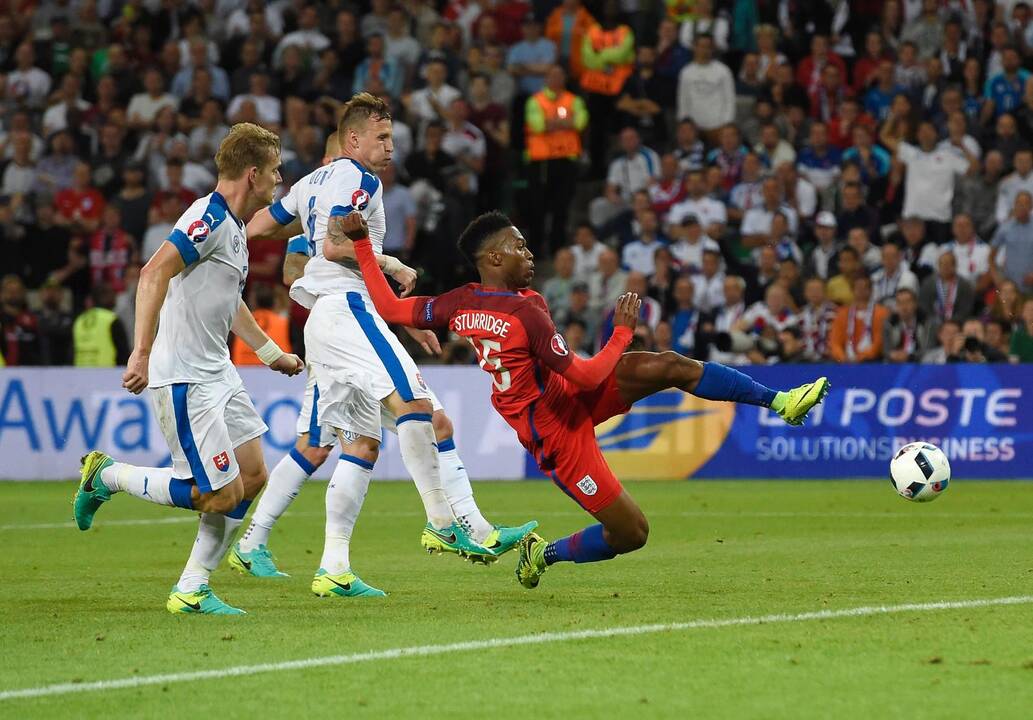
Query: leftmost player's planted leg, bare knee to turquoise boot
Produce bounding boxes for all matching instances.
[165,438,269,615]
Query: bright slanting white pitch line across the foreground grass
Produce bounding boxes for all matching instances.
[0,595,1033,701]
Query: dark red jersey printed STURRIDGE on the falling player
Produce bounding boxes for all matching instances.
[412,283,572,439]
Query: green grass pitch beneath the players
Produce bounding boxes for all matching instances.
[0,481,1033,720]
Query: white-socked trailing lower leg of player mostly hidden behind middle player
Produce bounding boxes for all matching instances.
[229,433,331,577]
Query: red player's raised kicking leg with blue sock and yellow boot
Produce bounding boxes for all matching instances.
[616,350,828,425]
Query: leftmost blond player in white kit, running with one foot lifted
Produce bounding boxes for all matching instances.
[73,123,303,615]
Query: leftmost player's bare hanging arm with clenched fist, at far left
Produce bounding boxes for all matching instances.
[122,240,190,395]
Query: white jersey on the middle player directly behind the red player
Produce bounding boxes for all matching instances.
[270,158,386,308]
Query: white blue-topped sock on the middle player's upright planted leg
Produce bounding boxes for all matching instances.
[319,456,373,575]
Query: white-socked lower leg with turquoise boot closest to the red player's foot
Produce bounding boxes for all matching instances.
[432,410,538,565]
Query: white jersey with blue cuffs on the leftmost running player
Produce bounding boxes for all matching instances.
[149,192,248,387]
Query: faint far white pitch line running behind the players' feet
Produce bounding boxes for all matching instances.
[0,510,1033,532]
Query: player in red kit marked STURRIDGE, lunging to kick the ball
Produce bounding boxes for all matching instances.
[323,213,828,588]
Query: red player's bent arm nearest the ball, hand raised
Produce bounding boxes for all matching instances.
[525,292,641,390]
